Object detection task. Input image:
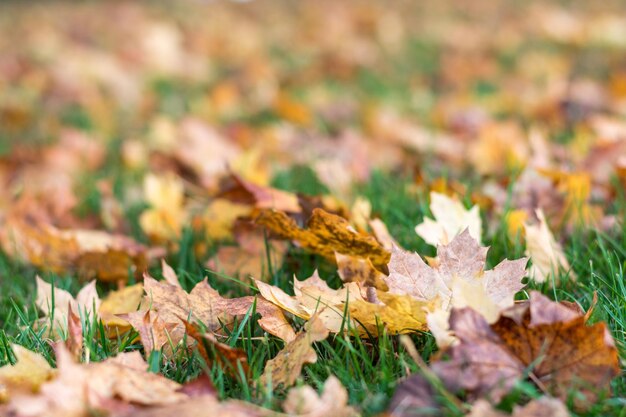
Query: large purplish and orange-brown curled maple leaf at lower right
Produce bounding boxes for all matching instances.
[431,291,619,402]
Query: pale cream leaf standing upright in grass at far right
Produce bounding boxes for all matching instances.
[525,210,576,282]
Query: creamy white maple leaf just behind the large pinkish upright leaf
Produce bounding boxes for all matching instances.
[415,192,482,246]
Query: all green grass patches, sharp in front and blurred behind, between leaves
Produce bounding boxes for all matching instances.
[0,2,626,417]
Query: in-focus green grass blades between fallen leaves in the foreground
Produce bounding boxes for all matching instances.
[0,170,626,416]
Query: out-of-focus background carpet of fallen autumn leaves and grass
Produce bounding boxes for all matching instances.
[0,0,626,237]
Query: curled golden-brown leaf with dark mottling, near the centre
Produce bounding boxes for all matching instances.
[256,208,390,271]
